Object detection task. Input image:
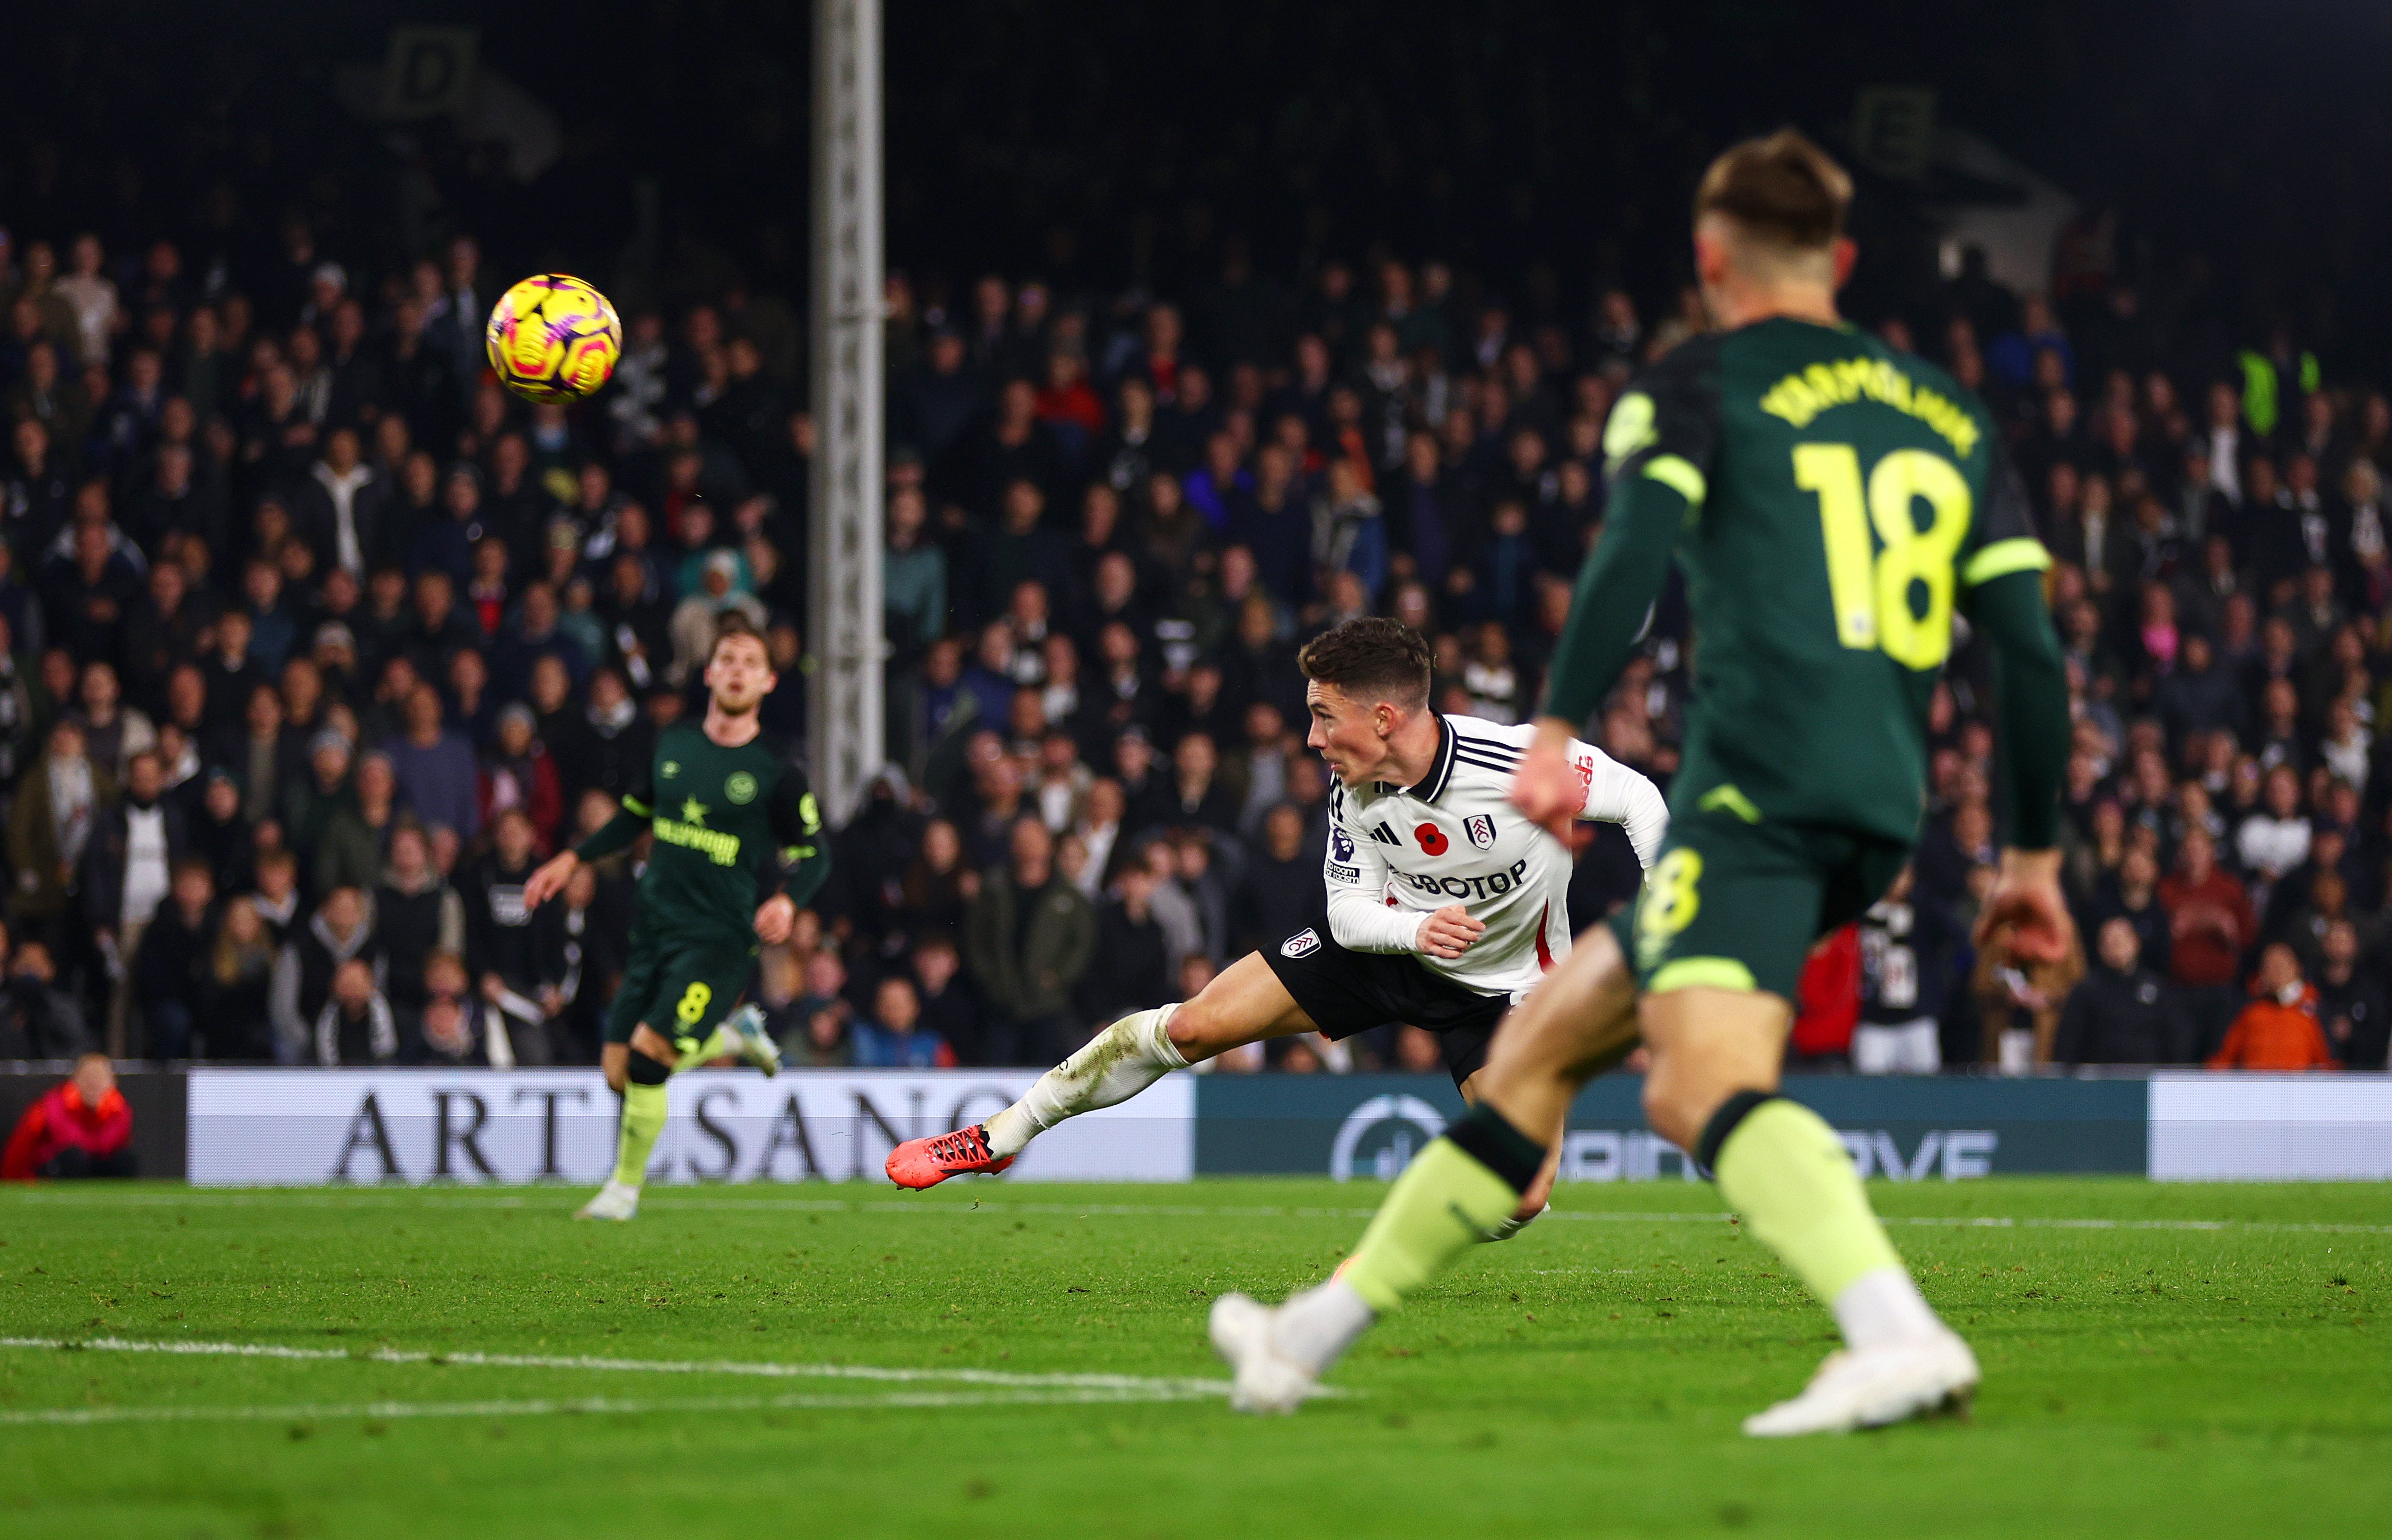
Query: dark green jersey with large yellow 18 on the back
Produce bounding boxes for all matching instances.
[1548,318,2050,839]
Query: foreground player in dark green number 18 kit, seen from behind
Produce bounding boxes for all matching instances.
[1213,131,2069,1435]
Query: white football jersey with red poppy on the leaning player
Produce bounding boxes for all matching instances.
[1323,715,1670,1000]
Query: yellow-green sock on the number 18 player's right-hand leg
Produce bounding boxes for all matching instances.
[1715,1097,1906,1306]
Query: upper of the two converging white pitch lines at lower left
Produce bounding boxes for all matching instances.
[0,1337,1230,1399]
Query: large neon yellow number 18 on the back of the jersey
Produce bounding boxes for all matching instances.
[1794,445,1976,670]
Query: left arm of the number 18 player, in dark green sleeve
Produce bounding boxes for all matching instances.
[1512,342,1720,832]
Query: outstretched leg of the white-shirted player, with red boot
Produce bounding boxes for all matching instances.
[888,952,1313,1189]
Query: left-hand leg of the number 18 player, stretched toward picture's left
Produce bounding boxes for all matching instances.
[1211,928,1636,1413]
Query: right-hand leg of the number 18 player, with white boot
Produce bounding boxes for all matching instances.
[1643,988,1978,1437]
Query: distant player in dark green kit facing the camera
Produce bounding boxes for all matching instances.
[524,614,830,1220]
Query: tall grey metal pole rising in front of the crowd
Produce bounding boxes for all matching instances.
[806,0,888,823]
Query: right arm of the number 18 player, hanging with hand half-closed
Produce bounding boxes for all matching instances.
[1959,443,2074,961]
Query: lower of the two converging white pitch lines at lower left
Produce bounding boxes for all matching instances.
[0,1380,1227,1428]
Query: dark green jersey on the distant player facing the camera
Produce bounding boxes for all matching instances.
[581,722,828,949]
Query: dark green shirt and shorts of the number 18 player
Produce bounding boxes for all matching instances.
[1545,318,2067,997]
